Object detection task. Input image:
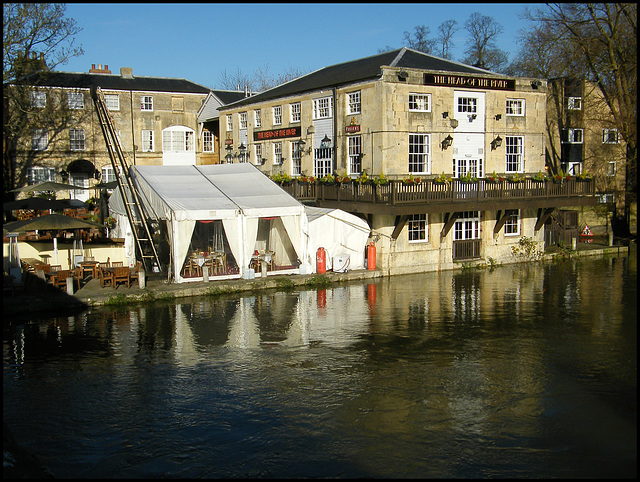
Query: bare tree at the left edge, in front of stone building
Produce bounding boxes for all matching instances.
[2,3,83,200]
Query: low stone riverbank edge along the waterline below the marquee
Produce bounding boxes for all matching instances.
[3,240,635,320]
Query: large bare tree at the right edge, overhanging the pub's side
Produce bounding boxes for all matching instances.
[527,3,638,236]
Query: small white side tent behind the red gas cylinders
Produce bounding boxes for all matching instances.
[305,206,370,270]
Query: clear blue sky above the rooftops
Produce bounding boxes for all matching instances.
[57,3,527,88]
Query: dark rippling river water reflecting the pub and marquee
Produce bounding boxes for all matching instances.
[3,253,637,478]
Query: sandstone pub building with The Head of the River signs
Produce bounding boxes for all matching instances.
[220,48,568,274]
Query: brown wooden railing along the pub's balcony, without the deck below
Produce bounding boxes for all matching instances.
[282,179,596,212]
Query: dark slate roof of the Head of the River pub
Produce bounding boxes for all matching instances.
[225,47,502,107]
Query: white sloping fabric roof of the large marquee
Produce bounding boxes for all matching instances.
[110,163,304,220]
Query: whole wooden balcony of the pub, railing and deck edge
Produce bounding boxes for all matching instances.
[282,179,597,215]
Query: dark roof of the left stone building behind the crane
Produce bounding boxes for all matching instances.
[15,70,211,94]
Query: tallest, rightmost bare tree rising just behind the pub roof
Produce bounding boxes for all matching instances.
[462,12,508,71]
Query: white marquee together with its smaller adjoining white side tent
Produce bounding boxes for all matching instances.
[109,163,370,282]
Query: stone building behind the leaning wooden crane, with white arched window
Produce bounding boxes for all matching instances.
[8,64,219,200]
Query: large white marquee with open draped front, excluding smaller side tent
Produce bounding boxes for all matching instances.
[109,163,306,282]
